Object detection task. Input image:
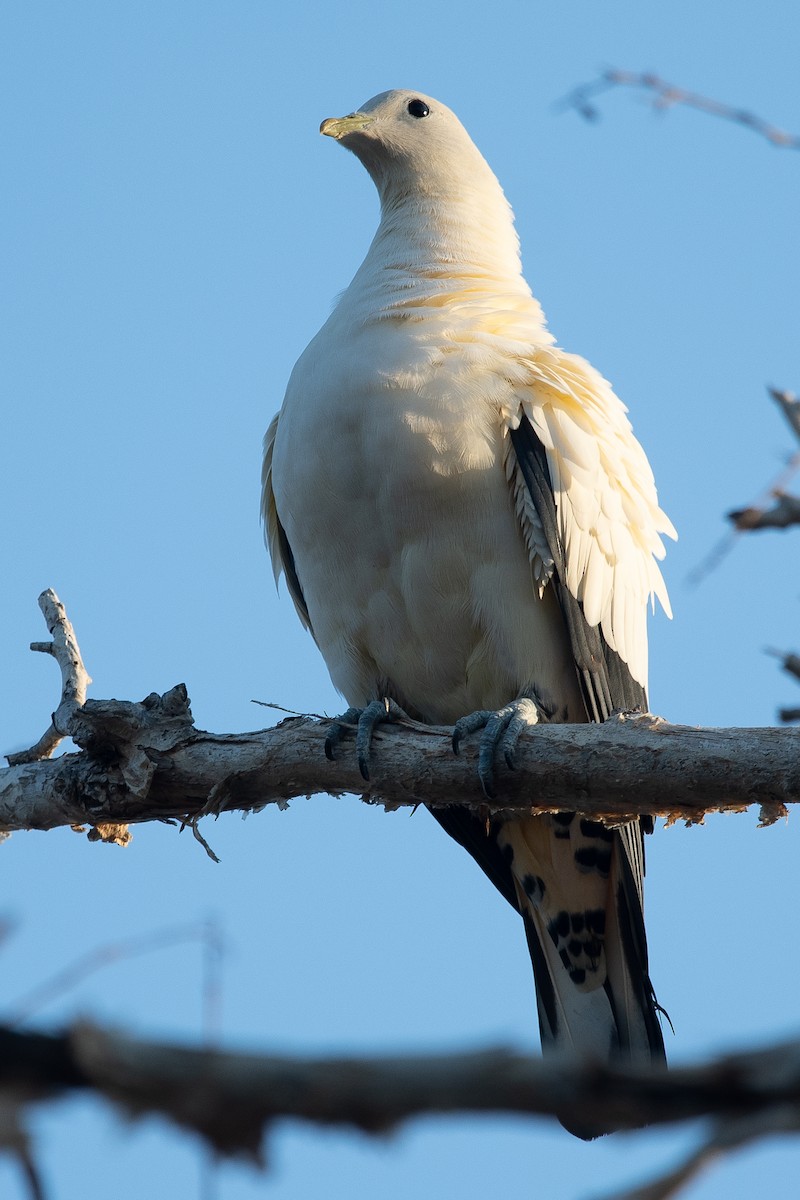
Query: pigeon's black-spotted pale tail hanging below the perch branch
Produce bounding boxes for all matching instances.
[498,814,664,1138]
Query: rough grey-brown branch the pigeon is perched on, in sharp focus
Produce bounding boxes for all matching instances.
[0,588,800,844]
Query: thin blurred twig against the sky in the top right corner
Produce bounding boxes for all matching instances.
[558,67,800,150]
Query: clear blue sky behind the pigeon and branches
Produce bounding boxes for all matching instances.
[0,0,800,1200]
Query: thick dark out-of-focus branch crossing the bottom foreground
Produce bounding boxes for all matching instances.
[0,1025,800,1200]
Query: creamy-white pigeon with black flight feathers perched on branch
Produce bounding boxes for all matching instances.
[263,90,674,1135]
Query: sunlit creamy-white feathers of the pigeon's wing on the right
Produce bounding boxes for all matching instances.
[504,347,676,689]
